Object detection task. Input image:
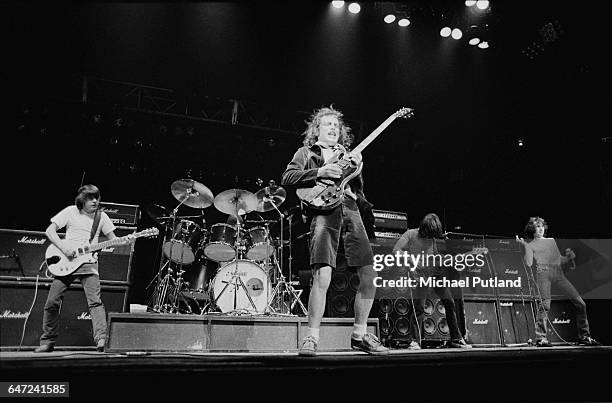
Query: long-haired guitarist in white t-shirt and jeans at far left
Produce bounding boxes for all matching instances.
[34,185,133,353]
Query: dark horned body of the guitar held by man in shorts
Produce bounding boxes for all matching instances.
[296,151,363,211]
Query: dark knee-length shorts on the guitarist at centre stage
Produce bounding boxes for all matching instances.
[310,196,374,268]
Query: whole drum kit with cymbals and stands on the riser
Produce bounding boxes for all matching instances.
[147,179,307,315]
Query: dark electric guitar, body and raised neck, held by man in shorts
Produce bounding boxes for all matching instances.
[296,108,414,211]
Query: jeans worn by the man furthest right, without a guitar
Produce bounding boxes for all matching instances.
[536,265,590,339]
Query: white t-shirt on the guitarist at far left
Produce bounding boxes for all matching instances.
[51,206,115,274]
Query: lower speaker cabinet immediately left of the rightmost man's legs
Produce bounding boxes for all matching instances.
[499,300,536,345]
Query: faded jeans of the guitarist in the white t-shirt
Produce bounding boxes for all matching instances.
[40,274,106,345]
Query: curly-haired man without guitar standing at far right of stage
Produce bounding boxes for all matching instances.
[516,217,600,347]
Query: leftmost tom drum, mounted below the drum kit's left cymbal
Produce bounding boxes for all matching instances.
[163,220,204,264]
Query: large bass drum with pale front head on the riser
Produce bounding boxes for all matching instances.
[211,260,272,313]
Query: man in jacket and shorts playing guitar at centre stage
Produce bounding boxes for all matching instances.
[282,106,389,356]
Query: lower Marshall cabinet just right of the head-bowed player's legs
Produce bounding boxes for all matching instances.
[464,300,501,346]
